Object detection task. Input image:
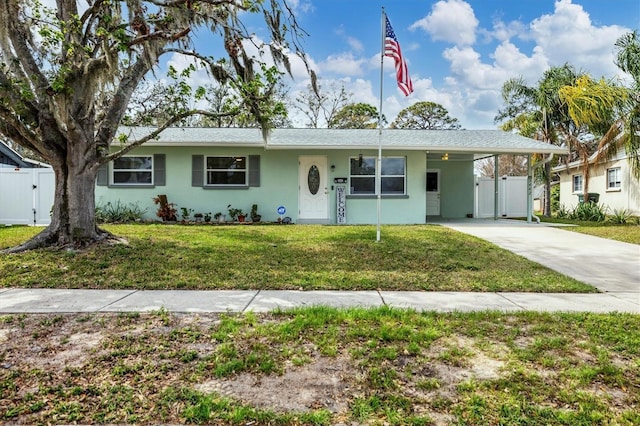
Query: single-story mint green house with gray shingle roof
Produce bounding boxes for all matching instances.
[96,128,567,224]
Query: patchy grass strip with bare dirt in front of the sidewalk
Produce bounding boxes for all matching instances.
[0,307,640,425]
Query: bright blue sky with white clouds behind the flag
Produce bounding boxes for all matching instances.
[169,0,640,129]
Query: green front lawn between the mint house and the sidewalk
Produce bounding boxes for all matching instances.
[0,224,595,292]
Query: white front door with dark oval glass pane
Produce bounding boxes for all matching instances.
[298,155,329,223]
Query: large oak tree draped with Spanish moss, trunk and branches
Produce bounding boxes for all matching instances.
[0,0,315,251]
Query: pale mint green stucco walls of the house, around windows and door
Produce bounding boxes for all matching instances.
[96,146,464,224]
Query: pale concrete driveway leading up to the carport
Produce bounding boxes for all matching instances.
[431,219,640,294]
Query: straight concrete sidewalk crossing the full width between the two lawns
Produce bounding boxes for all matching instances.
[0,289,640,314]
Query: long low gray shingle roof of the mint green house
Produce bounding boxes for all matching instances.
[119,127,568,154]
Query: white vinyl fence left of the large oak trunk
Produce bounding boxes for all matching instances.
[0,167,55,225]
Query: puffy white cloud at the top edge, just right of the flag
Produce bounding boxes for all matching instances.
[409,0,478,45]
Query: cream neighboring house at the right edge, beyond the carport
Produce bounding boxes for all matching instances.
[553,149,640,216]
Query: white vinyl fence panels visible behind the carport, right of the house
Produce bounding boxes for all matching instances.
[475,176,528,218]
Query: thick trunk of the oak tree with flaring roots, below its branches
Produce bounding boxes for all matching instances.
[4,140,111,253]
